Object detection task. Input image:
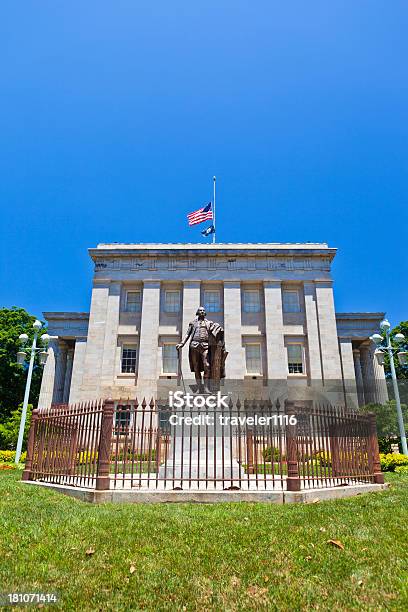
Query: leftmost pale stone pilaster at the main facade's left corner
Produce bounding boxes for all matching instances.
[82,282,109,400]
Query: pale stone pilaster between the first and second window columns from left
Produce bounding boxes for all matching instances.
[137,281,160,397]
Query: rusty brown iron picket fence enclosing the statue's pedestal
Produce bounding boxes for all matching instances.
[23,399,383,491]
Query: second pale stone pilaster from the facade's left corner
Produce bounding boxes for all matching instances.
[101,282,121,397]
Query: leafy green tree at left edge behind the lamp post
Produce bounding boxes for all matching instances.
[0,306,42,423]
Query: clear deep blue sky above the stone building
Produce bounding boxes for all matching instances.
[0,0,408,323]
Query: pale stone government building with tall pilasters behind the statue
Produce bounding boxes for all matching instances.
[39,243,387,408]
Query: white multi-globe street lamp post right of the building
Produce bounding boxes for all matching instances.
[370,319,408,455]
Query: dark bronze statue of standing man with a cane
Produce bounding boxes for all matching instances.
[176,306,228,393]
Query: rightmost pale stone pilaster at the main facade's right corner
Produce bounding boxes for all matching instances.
[316,281,341,382]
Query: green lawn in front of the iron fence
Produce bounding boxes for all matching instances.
[0,472,408,610]
